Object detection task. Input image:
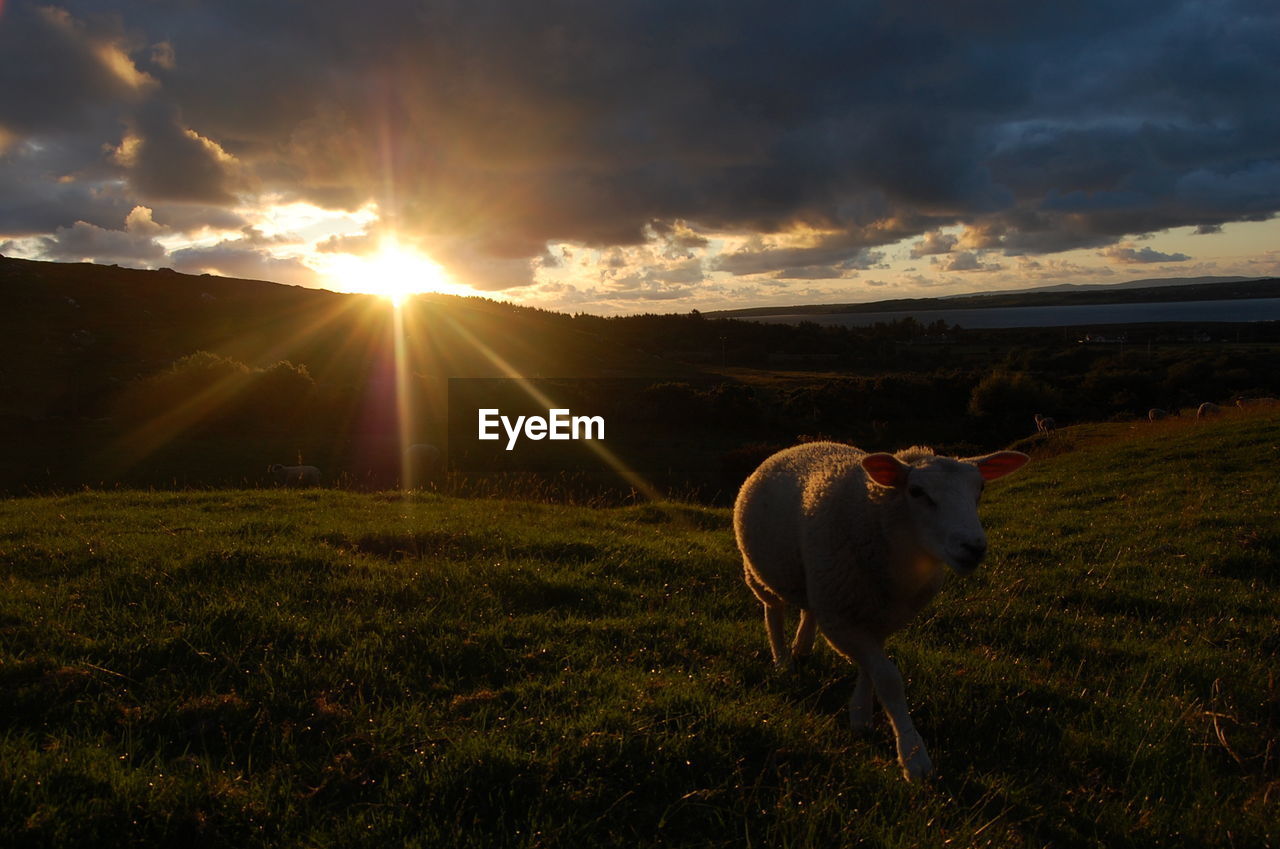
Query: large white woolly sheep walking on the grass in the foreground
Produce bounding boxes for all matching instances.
[733,442,1029,781]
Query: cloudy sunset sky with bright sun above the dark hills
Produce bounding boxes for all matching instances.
[0,0,1280,314]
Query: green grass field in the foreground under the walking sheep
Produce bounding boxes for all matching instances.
[0,414,1280,849]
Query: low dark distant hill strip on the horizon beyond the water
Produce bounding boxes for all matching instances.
[705,277,1280,318]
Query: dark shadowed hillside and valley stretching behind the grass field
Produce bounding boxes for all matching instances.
[0,260,1280,505]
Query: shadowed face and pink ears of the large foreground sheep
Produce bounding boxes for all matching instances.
[863,451,1028,575]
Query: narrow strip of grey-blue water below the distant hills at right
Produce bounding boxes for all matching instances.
[742,298,1280,330]
